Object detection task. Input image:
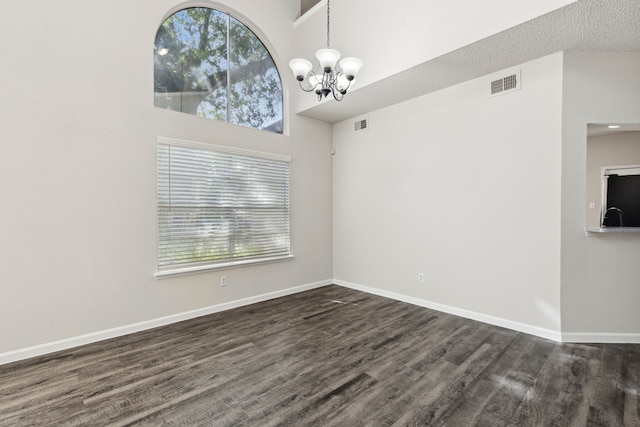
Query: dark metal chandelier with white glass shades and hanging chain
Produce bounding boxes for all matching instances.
[289,0,362,101]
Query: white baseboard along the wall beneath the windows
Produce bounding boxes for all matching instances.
[0,280,333,365]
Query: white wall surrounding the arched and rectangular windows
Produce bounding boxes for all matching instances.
[0,0,332,355]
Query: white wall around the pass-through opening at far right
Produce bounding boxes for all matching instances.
[562,52,640,342]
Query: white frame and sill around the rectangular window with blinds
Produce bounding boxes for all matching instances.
[154,137,294,279]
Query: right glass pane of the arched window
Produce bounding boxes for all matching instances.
[229,18,282,132]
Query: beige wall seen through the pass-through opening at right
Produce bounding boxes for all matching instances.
[585,132,640,227]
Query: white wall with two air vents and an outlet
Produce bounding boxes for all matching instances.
[333,54,562,336]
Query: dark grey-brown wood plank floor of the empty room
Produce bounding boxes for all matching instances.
[0,286,640,427]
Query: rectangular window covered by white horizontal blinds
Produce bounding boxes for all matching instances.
[157,138,291,276]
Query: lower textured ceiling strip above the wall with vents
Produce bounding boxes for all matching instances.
[300,0,640,123]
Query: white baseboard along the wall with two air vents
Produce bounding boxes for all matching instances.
[333,280,563,342]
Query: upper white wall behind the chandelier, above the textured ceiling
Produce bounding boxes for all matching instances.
[294,0,576,110]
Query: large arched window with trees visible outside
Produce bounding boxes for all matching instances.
[154,7,282,133]
